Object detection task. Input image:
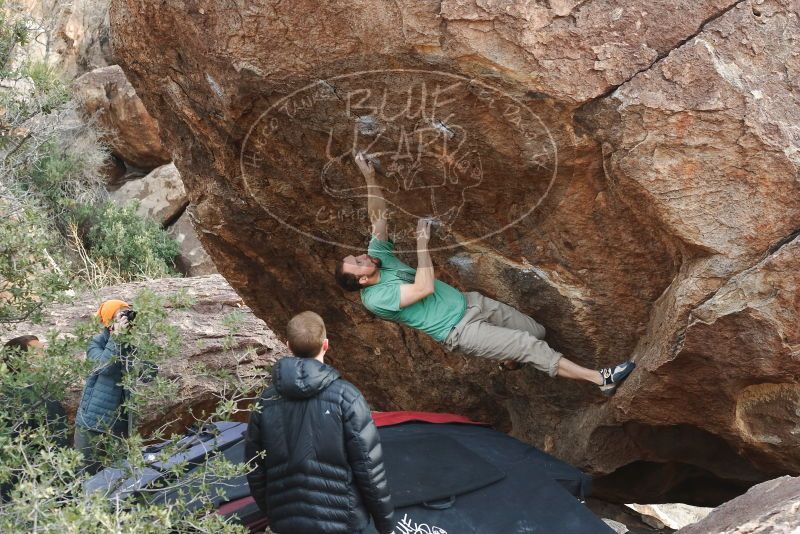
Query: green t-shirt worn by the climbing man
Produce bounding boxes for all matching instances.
[361,236,467,341]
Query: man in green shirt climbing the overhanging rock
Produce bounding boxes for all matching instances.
[335,153,636,395]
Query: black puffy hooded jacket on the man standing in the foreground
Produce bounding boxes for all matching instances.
[245,357,394,534]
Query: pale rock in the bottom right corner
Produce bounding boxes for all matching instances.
[678,477,800,534]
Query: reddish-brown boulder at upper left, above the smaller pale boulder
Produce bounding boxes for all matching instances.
[72,65,170,169]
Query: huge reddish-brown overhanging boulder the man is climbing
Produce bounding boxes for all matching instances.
[111,0,800,503]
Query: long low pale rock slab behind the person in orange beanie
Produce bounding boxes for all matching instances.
[2,275,288,432]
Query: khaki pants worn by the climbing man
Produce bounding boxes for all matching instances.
[442,291,561,376]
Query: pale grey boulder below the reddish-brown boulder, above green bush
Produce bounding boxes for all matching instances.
[110,163,188,224]
